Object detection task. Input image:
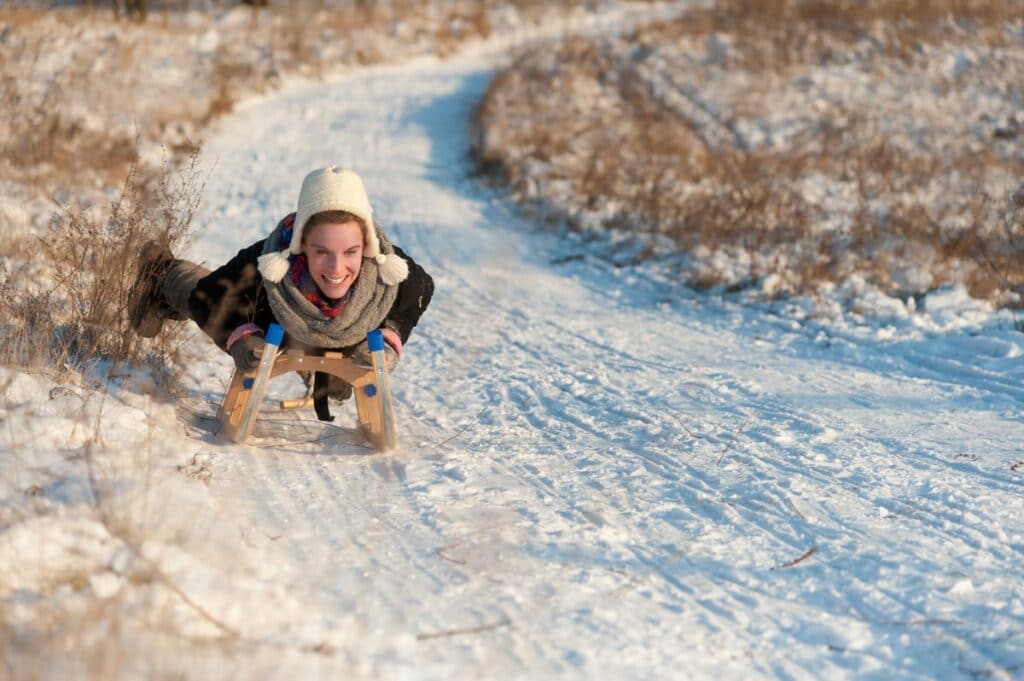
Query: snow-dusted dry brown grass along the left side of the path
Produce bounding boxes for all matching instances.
[0,0,630,376]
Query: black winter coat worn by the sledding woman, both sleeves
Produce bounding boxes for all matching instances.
[188,240,434,352]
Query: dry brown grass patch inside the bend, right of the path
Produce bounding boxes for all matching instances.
[474,0,1024,306]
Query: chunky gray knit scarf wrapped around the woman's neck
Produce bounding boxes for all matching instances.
[263,221,398,349]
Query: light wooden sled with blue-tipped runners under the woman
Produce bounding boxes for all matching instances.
[217,324,396,452]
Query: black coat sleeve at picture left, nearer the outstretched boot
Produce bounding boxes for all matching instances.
[188,241,273,350]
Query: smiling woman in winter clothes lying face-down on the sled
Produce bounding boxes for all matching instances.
[125,166,433,397]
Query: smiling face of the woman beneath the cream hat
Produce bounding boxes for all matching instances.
[303,220,362,298]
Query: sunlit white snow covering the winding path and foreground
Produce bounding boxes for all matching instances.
[0,2,1024,679]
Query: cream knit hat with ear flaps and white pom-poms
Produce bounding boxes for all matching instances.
[259,166,409,285]
